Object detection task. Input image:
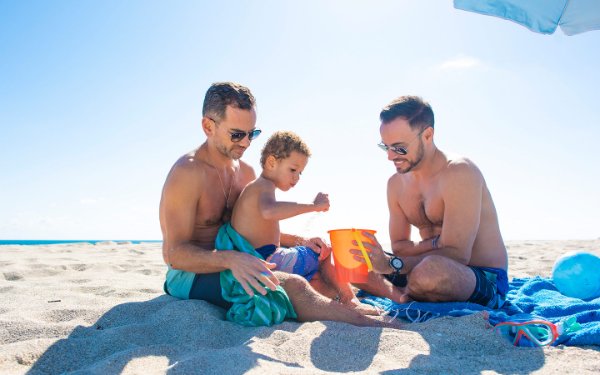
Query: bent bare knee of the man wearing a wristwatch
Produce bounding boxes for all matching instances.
[406,255,476,302]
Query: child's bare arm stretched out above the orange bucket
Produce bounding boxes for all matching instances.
[258,192,329,220]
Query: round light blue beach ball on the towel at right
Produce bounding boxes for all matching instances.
[552,251,600,300]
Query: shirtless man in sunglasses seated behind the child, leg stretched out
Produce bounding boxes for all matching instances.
[160,82,388,325]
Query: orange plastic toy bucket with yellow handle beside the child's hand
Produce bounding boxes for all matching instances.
[327,228,376,283]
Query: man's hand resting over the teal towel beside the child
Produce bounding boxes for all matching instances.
[225,251,279,297]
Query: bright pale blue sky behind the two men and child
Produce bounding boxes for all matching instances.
[0,0,600,243]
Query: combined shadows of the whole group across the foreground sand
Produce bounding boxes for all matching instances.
[28,295,544,374]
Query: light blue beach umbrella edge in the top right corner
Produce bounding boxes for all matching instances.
[454,0,600,35]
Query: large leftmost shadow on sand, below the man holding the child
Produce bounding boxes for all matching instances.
[28,295,299,374]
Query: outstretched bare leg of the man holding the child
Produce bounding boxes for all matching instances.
[275,272,399,328]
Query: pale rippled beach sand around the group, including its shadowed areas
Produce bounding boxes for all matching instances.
[0,240,600,374]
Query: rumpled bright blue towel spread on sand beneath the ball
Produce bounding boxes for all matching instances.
[363,276,600,346]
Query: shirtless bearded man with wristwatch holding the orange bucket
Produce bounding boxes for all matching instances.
[352,96,508,308]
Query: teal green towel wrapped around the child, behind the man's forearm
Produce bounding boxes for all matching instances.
[215,223,297,327]
